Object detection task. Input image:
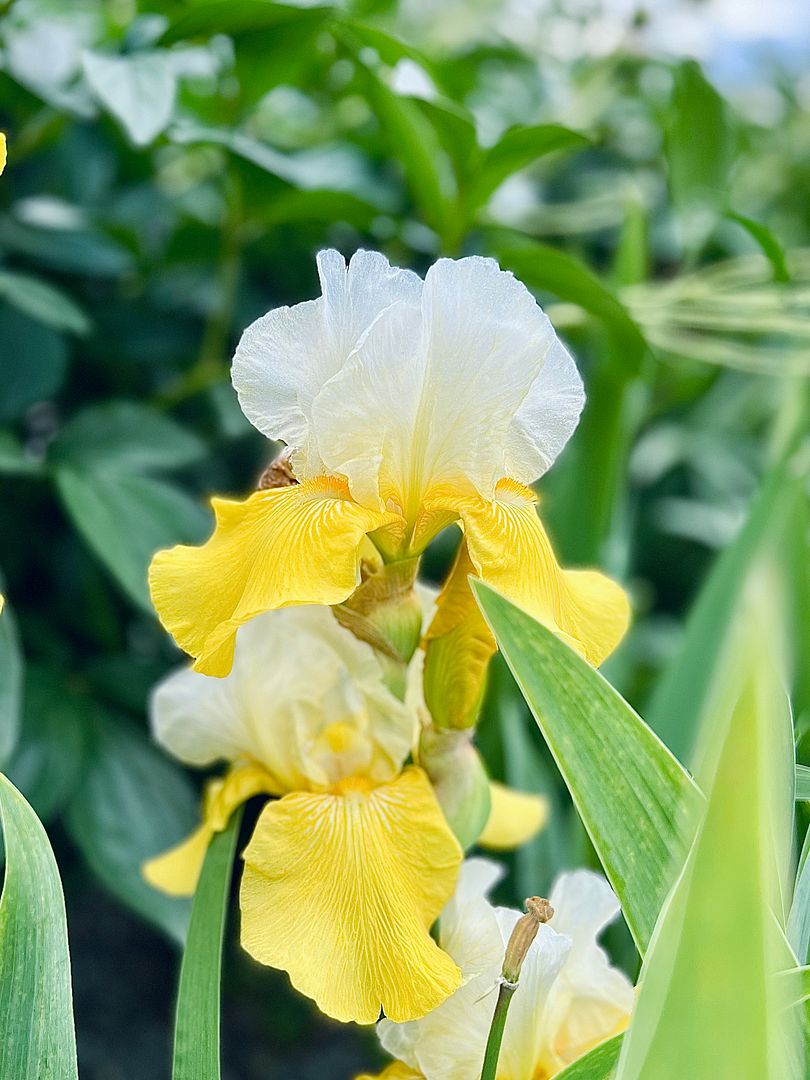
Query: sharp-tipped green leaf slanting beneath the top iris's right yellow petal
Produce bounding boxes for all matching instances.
[473,582,700,955]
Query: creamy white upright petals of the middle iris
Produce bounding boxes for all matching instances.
[151,607,416,791]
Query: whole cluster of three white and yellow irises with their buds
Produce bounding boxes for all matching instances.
[145,252,629,1062]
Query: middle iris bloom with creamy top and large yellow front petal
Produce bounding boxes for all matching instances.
[145,607,539,1023]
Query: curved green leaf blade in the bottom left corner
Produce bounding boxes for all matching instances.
[0,774,79,1080]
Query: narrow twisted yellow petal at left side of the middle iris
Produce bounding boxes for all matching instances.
[143,765,281,896]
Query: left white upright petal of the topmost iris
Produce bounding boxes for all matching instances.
[232,251,422,476]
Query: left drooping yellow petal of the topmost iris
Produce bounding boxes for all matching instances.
[149,477,393,676]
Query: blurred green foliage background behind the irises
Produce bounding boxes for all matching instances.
[0,0,810,1080]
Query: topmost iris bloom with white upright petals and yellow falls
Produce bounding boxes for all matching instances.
[150,251,629,678]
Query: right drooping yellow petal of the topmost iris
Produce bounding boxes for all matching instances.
[457,481,630,665]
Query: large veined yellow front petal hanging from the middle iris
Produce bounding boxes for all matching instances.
[241,767,461,1024]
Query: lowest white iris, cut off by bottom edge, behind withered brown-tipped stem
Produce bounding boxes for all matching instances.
[361,859,633,1080]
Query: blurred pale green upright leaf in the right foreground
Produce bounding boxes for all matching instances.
[617,583,805,1080]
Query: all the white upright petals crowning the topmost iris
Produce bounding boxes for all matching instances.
[233,252,584,511]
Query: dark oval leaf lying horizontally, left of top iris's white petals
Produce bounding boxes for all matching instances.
[49,401,206,472]
